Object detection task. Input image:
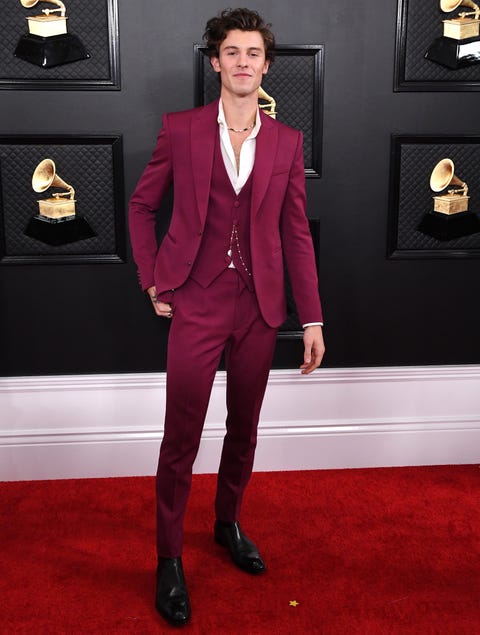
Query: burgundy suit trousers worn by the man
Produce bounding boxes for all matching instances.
[156,269,277,558]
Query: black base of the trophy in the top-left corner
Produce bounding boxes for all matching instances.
[14,33,90,68]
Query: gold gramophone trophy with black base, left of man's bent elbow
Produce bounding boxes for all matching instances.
[25,159,95,245]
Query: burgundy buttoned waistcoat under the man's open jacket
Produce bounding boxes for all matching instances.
[190,136,253,291]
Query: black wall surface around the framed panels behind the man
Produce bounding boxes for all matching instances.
[0,0,480,376]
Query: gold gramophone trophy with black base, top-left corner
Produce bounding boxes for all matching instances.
[14,0,90,68]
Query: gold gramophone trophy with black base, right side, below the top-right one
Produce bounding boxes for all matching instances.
[418,159,480,240]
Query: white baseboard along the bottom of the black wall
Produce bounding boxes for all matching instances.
[0,366,480,481]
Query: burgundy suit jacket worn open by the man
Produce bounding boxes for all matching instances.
[129,101,322,327]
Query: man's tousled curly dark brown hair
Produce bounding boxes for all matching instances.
[203,9,275,64]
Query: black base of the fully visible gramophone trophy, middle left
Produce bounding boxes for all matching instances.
[24,215,96,247]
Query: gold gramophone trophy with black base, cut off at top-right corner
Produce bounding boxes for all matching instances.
[425,0,480,70]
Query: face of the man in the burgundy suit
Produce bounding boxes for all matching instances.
[211,29,269,97]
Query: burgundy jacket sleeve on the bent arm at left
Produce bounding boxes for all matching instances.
[128,115,173,290]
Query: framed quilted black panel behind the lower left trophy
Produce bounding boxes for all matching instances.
[0,138,124,261]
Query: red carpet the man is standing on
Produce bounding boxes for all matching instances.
[0,466,480,635]
